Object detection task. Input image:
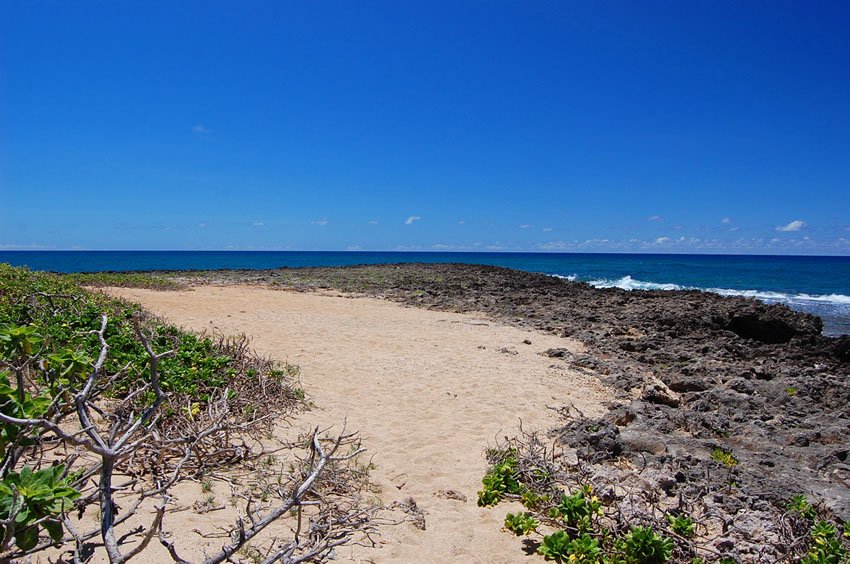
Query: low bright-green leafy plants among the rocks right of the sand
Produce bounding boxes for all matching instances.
[478,434,850,564]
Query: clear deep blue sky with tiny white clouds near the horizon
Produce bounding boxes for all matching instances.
[0,0,850,255]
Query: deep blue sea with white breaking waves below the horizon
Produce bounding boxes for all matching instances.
[0,251,850,335]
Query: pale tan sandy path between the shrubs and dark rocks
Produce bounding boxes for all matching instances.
[111,286,608,562]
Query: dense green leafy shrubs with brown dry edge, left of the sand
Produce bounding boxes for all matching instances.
[0,264,303,561]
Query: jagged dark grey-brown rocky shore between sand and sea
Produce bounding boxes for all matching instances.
[149,264,850,560]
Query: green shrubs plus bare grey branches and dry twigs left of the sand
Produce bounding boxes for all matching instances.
[0,264,373,564]
